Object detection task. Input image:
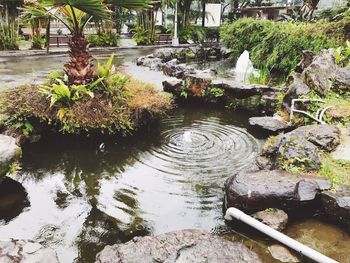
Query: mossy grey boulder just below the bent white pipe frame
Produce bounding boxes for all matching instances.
[257,124,340,171]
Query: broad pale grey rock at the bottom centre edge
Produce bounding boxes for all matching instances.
[96,230,261,263]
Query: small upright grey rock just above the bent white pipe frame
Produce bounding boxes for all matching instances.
[282,74,310,113]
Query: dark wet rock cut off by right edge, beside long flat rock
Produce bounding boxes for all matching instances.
[321,185,350,231]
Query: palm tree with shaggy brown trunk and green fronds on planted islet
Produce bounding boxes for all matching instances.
[22,0,150,85]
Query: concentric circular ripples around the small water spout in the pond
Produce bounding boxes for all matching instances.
[139,116,259,183]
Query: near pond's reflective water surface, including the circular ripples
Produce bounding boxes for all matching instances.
[0,108,259,262]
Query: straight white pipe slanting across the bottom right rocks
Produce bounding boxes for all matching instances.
[225,207,339,263]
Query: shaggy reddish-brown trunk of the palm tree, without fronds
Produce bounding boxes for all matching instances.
[64,35,96,85]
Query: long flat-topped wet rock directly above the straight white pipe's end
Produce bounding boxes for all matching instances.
[225,170,332,212]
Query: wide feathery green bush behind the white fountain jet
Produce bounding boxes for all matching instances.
[220,18,344,76]
